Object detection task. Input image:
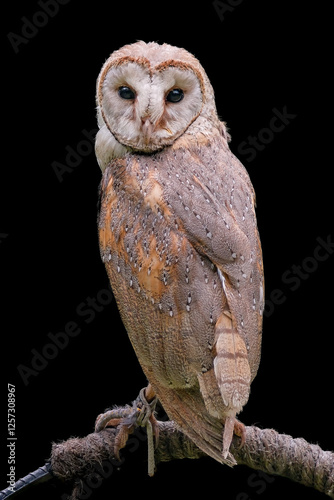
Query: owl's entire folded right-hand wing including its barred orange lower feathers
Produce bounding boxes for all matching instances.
[151,133,264,456]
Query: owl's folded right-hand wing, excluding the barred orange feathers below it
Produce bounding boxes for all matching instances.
[157,135,264,379]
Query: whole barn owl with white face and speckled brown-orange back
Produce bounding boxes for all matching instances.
[95,41,264,462]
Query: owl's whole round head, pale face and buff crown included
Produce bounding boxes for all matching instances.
[96,42,218,165]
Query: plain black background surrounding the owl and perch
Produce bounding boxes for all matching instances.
[0,0,334,500]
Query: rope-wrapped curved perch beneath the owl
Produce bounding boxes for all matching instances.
[51,421,334,500]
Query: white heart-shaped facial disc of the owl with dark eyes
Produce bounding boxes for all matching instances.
[98,60,203,152]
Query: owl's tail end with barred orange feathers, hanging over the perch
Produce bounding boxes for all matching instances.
[141,311,251,465]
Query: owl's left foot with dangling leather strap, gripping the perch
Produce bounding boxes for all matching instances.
[95,384,159,476]
